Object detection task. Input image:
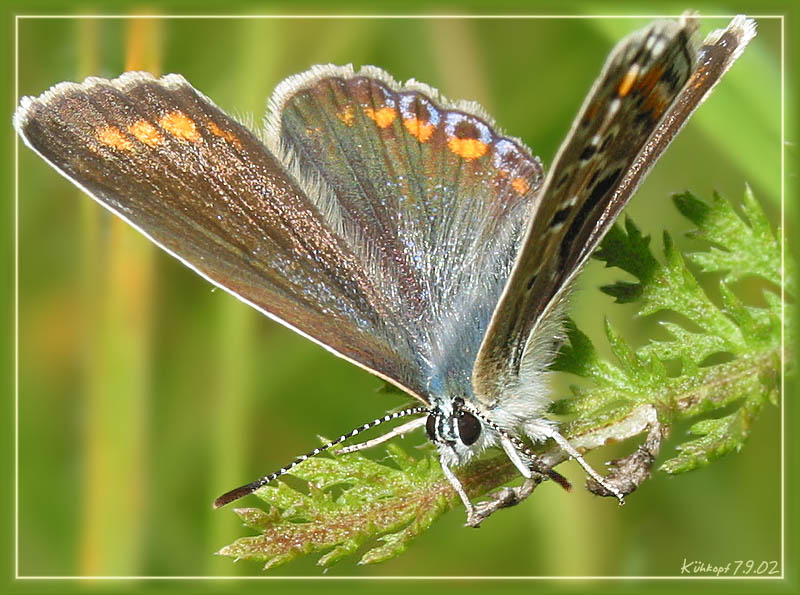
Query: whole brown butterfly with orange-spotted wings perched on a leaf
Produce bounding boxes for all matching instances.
[14,14,755,525]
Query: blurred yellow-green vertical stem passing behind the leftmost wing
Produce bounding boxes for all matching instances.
[77,19,161,575]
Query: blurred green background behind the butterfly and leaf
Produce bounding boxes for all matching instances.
[10,6,794,576]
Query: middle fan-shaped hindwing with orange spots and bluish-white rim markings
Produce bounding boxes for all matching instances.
[270,67,542,391]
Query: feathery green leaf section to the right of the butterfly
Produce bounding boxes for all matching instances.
[592,188,782,473]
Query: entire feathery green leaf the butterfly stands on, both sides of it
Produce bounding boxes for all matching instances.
[219,189,794,568]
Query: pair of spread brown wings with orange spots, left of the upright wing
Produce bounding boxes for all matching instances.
[15,66,541,402]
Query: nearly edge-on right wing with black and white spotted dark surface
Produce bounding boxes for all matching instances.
[473,17,752,401]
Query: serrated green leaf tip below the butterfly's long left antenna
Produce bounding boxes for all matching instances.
[219,445,452,567]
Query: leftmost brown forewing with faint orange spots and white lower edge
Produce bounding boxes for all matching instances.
[15,73,424,394]
